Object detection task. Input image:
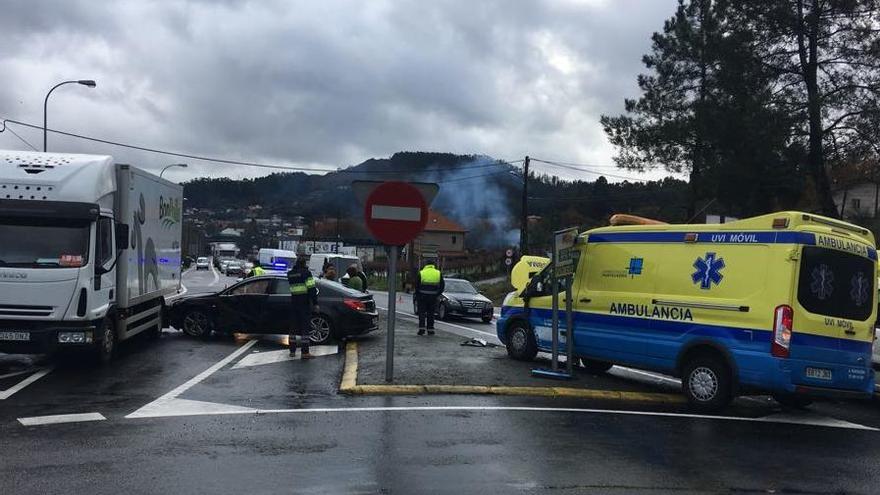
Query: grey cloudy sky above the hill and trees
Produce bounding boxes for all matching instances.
[0,0,676,179]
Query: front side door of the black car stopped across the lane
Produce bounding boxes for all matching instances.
[217,279,272,333]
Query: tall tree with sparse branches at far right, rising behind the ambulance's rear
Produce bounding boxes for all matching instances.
[733,0,880,217]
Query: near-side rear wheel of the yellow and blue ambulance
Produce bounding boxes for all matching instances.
[681,355,733,412]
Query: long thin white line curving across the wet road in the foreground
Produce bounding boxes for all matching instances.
[126,406,878,431]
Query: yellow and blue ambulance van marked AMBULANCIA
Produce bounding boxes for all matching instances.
[497,212,877,411]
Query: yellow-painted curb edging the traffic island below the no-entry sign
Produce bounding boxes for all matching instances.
[339,341,685,404]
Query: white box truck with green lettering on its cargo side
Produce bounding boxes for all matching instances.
[0,150,183,362]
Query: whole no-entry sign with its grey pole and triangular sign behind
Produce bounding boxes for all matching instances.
[352,181,439,383]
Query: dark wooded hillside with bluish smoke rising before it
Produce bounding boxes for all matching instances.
[184,152,686,247]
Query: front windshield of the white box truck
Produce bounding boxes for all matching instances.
[0,218,90,268]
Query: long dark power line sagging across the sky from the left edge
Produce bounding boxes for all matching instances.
[0,119,522,175]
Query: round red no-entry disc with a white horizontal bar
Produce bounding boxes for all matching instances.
[364,181,428,246]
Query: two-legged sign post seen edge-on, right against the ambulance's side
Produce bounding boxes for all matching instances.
[532,228,578,379]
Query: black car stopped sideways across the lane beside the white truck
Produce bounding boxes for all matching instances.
[170,275,379,344]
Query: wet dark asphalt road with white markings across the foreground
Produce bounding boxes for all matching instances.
[0,271,880,494]
